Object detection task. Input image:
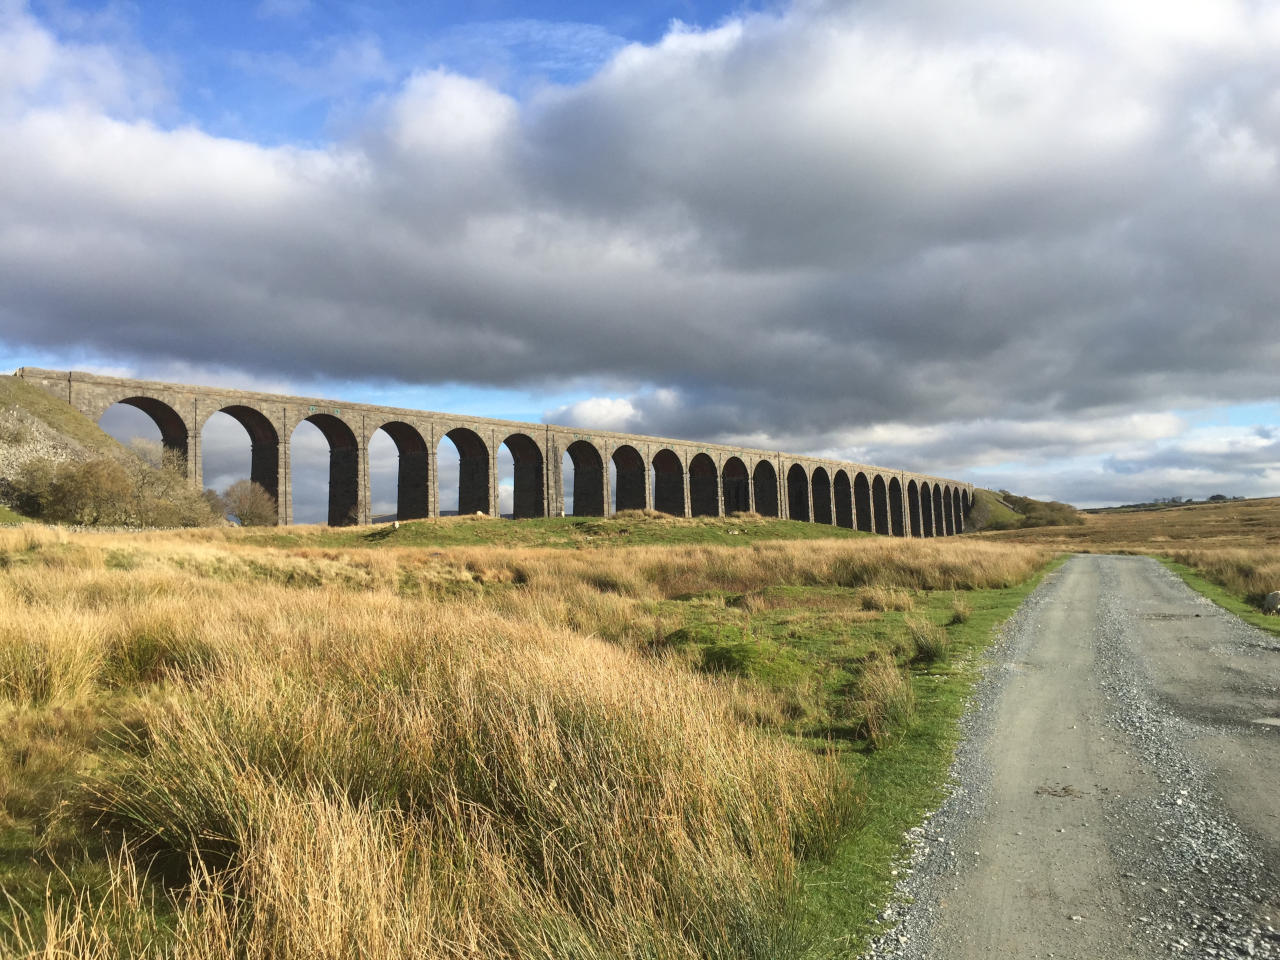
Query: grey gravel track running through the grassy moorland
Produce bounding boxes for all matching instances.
[872,556,1280,960]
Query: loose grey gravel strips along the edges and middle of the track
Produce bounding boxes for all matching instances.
[863,557,1280,959]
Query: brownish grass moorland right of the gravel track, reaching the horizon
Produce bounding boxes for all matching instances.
[980,498,1280,634]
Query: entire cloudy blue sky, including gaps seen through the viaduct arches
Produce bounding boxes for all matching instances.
[0,0,1280,518]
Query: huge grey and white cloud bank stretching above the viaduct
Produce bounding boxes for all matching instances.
[0,0,1280,512]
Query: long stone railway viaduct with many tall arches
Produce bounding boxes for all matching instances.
[18,367,973,536]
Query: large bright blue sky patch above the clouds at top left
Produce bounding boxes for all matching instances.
[32,0,763,143]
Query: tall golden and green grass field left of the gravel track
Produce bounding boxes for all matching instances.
[0,520,1050,960]
